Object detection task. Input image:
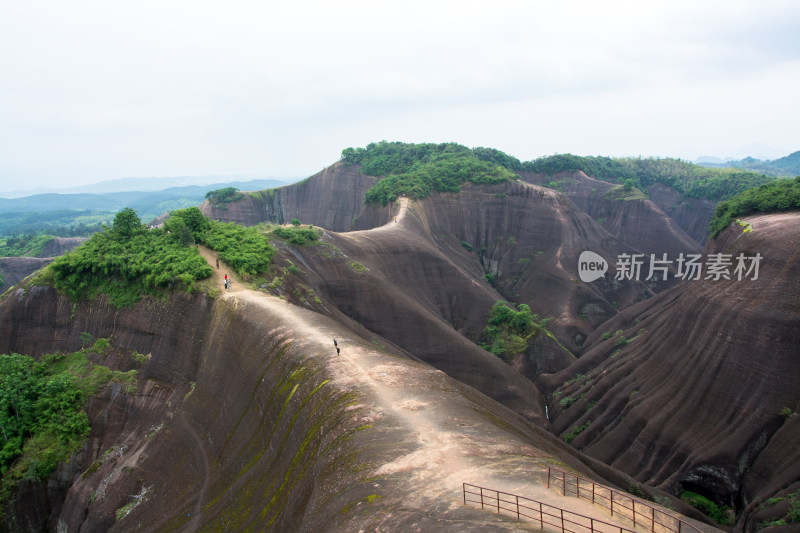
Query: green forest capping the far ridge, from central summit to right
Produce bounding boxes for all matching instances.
[341,141,775,205]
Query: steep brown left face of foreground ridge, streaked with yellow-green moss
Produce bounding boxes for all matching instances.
[0,287,390,531]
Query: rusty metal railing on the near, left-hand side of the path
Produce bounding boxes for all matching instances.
[462,483,636,533]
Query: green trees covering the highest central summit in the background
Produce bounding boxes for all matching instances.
[342,141,517,205]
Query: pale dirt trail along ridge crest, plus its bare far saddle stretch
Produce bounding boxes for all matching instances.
[189,207,708,529]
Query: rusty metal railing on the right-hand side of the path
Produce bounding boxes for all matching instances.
[547,468,701,533]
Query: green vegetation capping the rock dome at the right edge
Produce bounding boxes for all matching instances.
[708,176,800,239]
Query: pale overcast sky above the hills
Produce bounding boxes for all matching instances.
[0,0,800,191]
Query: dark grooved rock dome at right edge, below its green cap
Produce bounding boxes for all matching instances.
[545,213,800,523]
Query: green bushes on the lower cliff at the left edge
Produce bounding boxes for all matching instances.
[0,339,136,500]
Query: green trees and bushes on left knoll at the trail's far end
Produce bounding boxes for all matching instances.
[43,207,274,307]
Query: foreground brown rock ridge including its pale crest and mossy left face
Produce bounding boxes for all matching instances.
[0,258,716,531]
